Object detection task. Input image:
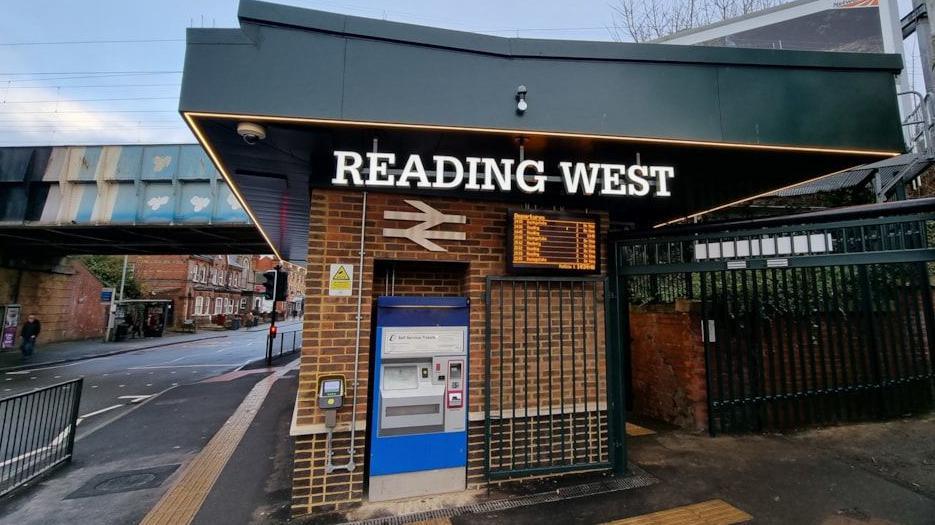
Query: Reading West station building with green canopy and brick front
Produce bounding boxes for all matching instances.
[180,0,931,514]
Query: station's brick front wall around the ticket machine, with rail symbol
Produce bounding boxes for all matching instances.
[292,190,607,514]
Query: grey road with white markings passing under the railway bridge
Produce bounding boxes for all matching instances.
[0,321,301,439]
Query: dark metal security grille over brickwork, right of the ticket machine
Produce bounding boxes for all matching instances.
[485,277,611,479]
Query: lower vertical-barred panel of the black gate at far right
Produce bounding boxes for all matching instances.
[700,263,933,432]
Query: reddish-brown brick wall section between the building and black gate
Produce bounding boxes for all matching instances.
[630,301,708,430]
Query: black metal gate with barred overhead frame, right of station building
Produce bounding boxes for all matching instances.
[617,203,935,434]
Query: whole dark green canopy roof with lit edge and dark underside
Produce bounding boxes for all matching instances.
[180,0,903,261]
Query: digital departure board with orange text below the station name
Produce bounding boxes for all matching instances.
[507,210,601,273]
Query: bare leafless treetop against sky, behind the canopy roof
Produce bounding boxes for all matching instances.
[610,0,788,42]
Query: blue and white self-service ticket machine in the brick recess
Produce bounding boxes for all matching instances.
[368,297,470,501]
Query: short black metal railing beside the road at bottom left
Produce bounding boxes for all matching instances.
[0,378,84,496]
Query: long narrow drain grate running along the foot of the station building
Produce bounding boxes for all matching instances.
[345,464,659,525]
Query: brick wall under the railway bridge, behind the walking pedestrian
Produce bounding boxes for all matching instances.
[0,260,107,345]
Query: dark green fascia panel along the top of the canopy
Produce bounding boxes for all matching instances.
[180,1,903,151]
